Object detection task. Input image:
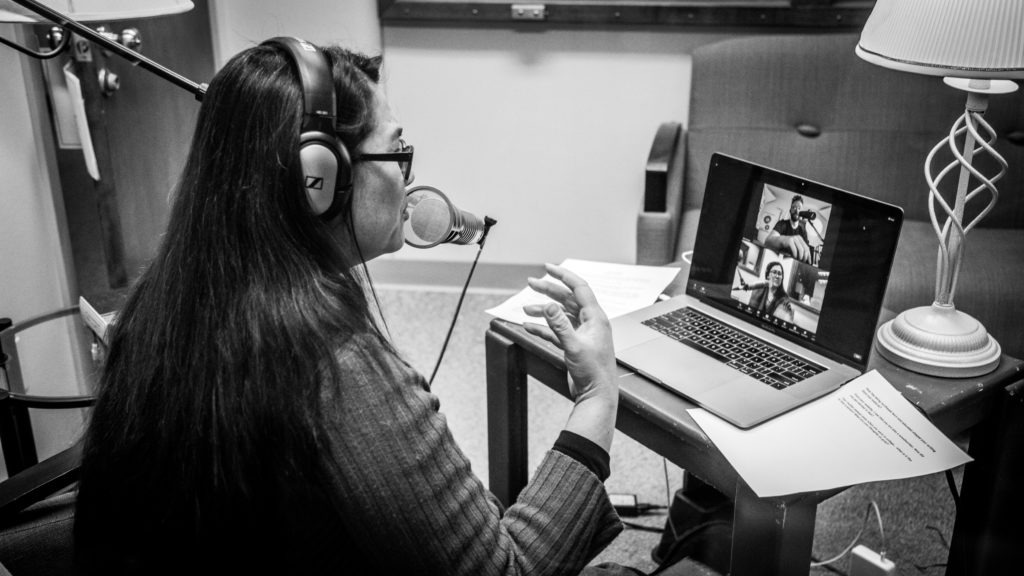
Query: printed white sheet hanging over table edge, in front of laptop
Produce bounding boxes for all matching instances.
[689,370,972,497]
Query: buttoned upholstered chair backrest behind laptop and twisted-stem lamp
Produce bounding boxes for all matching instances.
[680,34,1024,226]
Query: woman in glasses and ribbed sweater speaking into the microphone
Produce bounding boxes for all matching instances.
[75,39,622,575]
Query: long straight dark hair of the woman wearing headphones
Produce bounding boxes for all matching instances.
[75,39,393,574]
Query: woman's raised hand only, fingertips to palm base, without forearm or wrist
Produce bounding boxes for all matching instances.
[523,264,618,400]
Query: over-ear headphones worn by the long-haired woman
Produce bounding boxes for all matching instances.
[261,36,352,219]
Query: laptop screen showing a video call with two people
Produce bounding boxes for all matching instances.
[686,154,903,369]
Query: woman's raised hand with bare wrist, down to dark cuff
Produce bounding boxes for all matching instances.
[523,264,618,451]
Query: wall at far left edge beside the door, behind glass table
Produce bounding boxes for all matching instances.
[0,24,89,477]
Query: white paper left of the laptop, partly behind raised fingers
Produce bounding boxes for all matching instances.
[486,258,679,324]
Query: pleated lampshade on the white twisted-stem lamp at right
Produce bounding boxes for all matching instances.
[856,0,1024,79]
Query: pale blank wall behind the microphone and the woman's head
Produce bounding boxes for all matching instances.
[205,0,726,264]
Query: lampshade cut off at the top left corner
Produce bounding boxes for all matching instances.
[0,0,193,23]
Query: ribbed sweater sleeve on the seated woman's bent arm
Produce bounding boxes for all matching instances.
[322,339,622,576]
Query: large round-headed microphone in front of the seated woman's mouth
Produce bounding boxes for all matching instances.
[403,186,495,248]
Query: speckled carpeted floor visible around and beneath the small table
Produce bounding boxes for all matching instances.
[378,285,963,575]
